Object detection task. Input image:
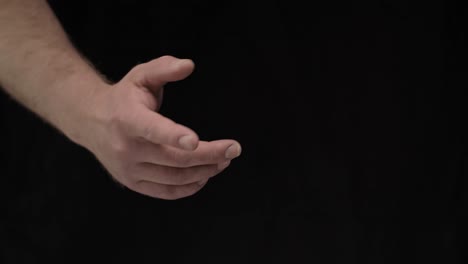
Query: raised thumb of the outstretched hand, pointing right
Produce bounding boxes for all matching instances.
[124,56,195,93]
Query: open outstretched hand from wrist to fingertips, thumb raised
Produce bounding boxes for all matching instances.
[77,56,241,200]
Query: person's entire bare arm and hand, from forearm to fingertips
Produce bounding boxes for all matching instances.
[0,0,241,200]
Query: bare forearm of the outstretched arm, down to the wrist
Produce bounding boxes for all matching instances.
[0,0,106,144]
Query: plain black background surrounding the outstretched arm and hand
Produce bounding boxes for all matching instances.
[0,0,468,263]
